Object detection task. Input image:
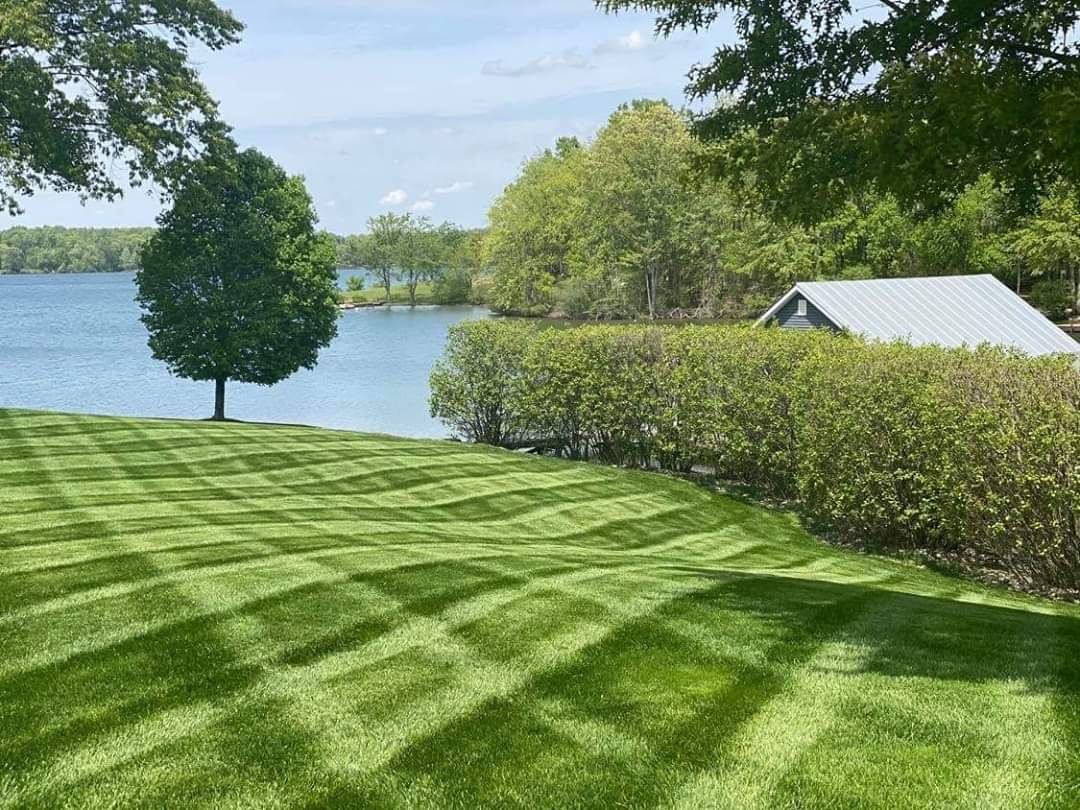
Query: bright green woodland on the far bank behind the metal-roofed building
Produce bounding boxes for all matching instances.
[484,102,1080,326]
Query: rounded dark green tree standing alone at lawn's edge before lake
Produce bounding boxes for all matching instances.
[137,149,338,420]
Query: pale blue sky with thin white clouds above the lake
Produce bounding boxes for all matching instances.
[21,0,723,233]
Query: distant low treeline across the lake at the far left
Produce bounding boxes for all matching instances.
[0,227,153,273]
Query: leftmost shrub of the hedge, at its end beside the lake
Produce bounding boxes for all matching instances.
[431,321,536,445]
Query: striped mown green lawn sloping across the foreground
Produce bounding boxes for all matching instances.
[0,410,1080,810]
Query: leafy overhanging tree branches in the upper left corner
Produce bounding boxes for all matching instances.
[0,0,241,213]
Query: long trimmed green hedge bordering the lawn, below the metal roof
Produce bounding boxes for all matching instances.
[431,321,1080,589]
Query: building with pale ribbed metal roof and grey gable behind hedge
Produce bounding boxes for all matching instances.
[757,275,1080,355]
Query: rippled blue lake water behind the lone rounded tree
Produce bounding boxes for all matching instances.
[0,272,488,436]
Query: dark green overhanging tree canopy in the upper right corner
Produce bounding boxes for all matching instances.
[597,0,1080,221]
